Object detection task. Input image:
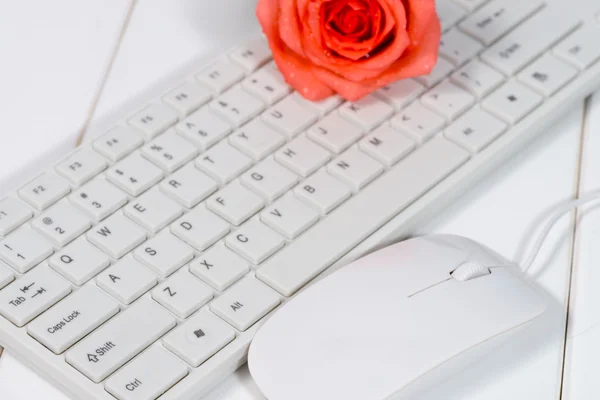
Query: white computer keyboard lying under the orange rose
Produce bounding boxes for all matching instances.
[0,0,600,400]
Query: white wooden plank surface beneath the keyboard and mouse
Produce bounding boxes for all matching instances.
[0,0,600,400]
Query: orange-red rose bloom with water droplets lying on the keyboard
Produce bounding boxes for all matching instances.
[257,0,440,101]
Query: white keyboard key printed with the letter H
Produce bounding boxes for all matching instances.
[275,136,331,177]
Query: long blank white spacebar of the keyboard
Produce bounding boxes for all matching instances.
[256,136,469,296]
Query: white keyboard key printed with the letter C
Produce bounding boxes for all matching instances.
[225,219,285,265]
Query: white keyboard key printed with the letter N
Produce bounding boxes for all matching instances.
[327,147,383,192]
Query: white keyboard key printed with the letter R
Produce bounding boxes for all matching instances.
[160,164,218,208]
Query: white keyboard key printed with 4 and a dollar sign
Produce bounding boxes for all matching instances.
[106,154,163,196]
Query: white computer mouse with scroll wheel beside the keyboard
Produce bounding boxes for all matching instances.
[248,235,549,400]
